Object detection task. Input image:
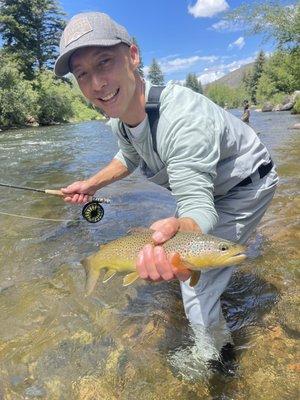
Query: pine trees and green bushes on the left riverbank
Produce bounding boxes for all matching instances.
[0,0,103,129]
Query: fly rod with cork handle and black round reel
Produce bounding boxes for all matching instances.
[0,183,110,223]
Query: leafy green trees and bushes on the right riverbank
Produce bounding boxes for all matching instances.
[205,2,300,113]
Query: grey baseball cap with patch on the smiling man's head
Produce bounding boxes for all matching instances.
[54,12,132,76]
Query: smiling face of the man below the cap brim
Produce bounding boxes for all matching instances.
[70,44,139,122]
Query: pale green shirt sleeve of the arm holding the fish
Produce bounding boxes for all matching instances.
[162,113,220,233]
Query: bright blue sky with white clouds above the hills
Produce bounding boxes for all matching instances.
[59,0,294,84]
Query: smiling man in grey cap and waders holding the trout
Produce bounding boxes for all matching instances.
[55,12,277,372]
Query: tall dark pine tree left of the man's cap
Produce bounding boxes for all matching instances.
[0,0,65,79]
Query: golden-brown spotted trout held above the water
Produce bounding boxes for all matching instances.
[81,229,246,296]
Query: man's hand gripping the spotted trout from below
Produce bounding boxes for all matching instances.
[136,217,195,282]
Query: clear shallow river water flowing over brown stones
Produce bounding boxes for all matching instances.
[0,110,300,400]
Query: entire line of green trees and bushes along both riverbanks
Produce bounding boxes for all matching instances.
[0,0,300,128]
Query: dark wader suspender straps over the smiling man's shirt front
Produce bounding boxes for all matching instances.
[119,86,165,153]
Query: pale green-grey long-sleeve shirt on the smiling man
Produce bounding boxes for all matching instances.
[110,82,270,233]
